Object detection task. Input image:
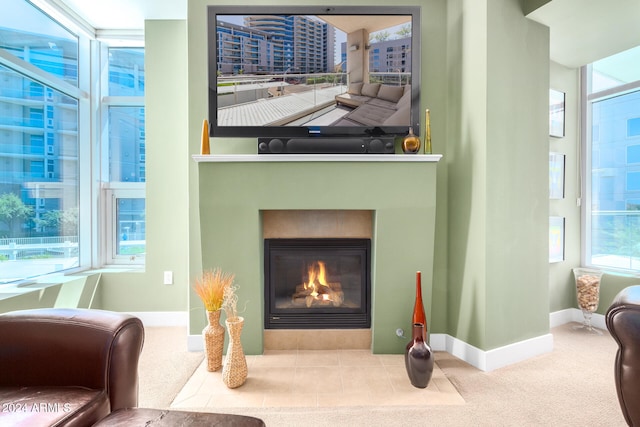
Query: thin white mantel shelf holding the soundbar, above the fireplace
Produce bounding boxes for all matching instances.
[192,154,442,163]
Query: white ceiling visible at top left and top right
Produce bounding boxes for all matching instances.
[57,0,640,67]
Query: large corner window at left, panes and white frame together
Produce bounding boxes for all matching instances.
[0,0,146,284]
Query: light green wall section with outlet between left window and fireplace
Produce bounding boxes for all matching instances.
[100,21,191,311]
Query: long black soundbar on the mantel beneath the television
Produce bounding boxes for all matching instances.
[258,137,395,154]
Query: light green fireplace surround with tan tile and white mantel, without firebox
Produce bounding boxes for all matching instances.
[190,154,440,354]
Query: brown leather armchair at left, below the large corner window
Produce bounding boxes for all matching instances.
[0,308,144,426]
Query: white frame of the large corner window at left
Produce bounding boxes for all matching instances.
[0,0,146,287]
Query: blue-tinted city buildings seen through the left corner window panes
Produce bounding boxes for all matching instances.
[0,0,145,283]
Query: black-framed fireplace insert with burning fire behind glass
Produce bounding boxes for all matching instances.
[264,238,371,329]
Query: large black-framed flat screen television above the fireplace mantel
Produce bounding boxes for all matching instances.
[208,6,420,138]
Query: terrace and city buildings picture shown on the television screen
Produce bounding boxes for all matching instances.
[214,14,412,126]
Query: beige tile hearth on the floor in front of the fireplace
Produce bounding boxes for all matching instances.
[171,350,465,410]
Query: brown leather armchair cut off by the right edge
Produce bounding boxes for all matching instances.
[605,286,640,426]
